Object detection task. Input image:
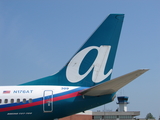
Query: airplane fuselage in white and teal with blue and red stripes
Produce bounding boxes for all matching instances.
[0,86,115,120]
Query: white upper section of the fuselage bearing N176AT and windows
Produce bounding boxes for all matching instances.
[0,86,77,105]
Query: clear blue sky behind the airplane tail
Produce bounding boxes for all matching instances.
[0,0,160,119]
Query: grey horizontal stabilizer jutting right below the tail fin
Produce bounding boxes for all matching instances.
[80,69,148,96]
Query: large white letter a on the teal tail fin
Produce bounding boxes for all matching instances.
[66,46,112,83]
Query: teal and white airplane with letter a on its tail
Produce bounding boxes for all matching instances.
[0,14,147,120]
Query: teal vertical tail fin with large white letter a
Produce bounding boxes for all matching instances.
[21,14,124,87]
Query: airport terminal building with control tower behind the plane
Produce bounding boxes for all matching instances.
[60,96,140,120]
